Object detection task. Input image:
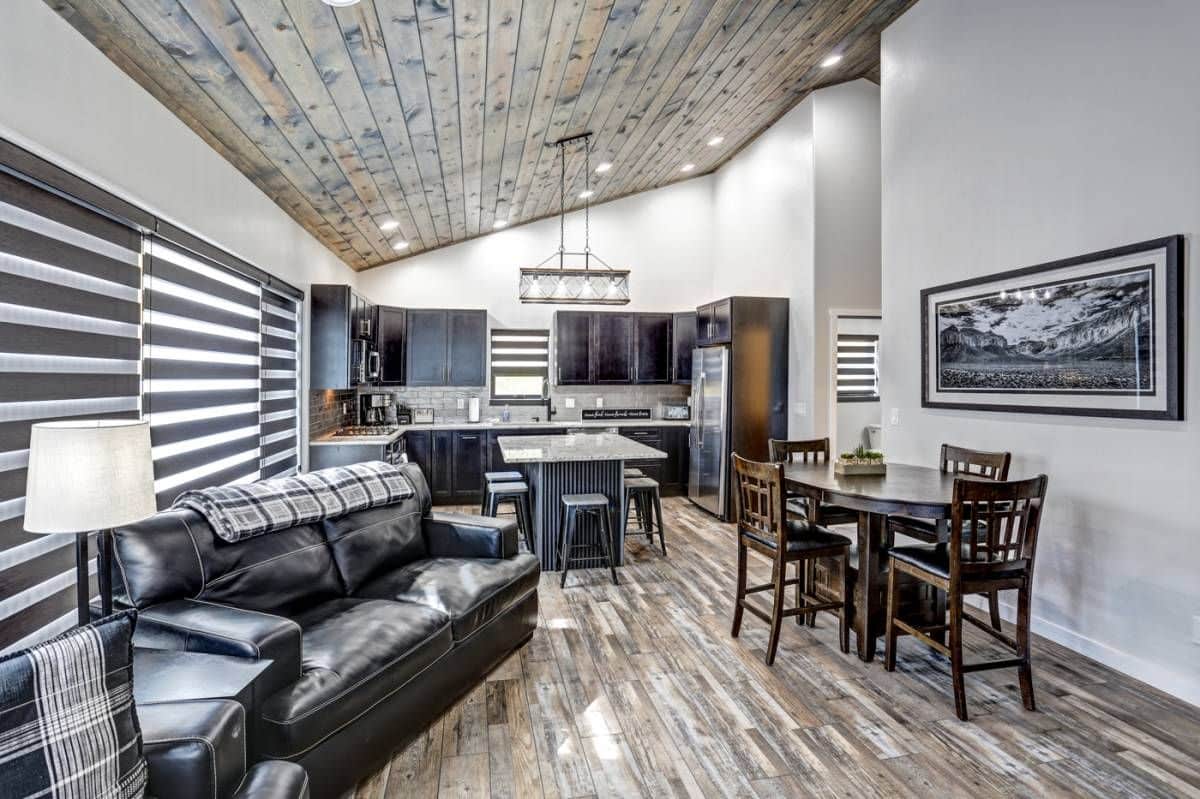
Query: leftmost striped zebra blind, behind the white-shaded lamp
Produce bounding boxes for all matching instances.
[0,174,142,650]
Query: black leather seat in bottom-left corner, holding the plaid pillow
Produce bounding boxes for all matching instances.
[137,699,308,799]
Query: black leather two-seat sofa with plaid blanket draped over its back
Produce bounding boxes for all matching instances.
[113,464,539,797]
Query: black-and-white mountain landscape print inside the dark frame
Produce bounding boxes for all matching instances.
[935,265,1156,396]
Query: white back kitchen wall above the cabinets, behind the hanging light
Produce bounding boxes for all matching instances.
[359,176,713,328]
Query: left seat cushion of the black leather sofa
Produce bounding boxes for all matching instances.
[262,599,454,759]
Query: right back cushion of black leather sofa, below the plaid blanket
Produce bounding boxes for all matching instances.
[325,497,428,594]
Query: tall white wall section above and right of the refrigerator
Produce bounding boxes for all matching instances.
[713,80,881,438]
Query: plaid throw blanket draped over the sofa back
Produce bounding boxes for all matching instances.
[172,461,415,543]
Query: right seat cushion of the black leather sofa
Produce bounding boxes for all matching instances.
[359,553,539,641]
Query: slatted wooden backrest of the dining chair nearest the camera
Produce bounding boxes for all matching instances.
[950,475,1046,581]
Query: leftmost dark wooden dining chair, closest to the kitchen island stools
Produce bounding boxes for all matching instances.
[731,453,852,666]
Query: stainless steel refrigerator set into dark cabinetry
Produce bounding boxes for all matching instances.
[688,347,730,517]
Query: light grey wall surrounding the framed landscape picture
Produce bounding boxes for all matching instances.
[882,0,1200,703]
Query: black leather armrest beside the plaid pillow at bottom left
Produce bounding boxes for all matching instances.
[137,699,246,799]
